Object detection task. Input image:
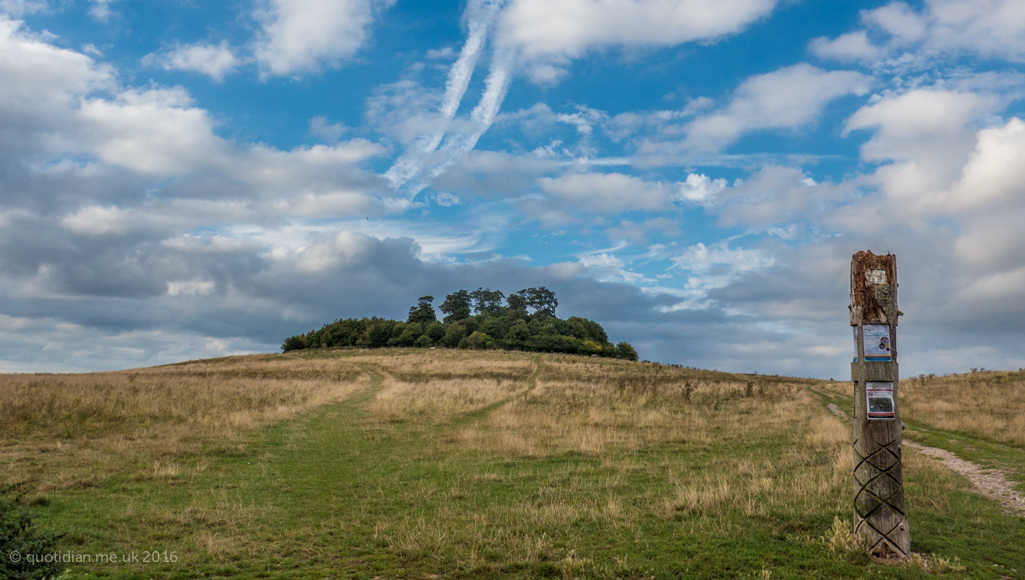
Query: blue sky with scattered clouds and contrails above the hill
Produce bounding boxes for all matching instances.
[0,0,1025,379]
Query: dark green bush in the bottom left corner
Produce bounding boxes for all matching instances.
[0,487,63,580]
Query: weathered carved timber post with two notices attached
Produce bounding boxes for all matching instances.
[851,252,911,558]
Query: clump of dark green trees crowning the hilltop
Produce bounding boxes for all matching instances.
[281,286,638,361]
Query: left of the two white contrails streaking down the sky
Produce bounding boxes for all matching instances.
[384,0,506,197]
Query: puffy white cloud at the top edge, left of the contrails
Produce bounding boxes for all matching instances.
[253,0,395,76]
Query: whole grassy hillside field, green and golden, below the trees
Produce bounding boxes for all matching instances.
[0,349,1025,579]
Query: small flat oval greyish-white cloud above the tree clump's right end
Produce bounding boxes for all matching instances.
[538,173,668,213]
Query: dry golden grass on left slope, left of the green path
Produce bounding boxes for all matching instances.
[0,356,369,492]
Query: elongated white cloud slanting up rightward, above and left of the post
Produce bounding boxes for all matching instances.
[687,64,872,150]
